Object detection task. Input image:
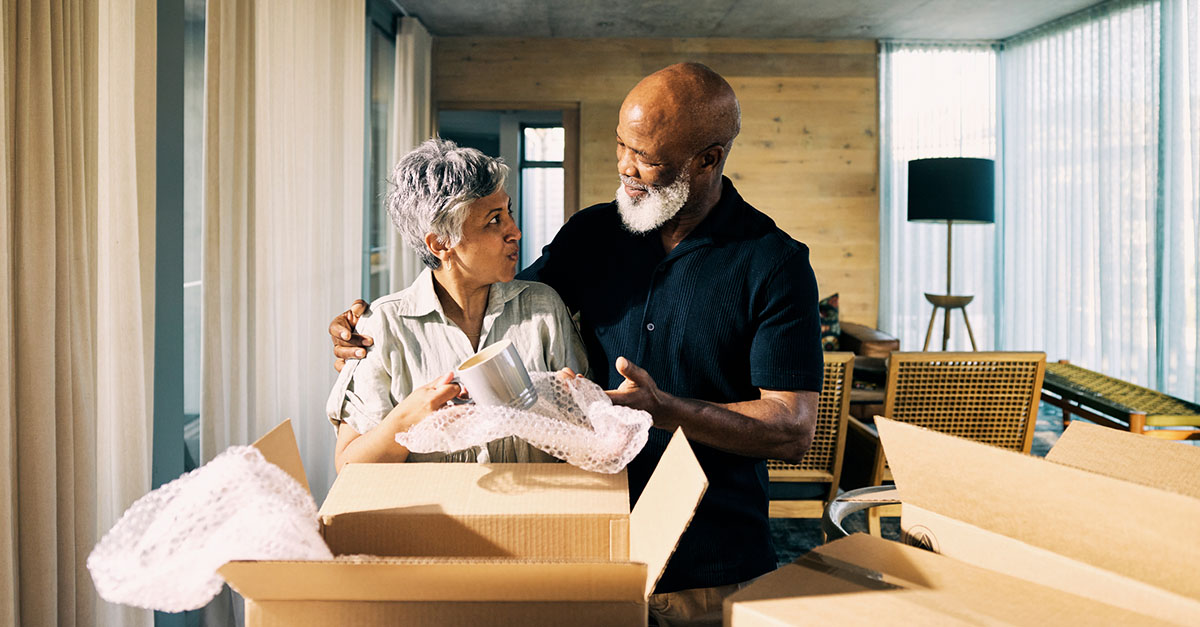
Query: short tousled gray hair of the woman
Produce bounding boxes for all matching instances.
[386,137,509,270]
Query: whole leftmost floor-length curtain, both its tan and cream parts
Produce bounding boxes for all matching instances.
[0,0,155,625]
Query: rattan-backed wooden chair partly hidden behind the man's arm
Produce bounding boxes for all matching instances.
[767,352,854,518]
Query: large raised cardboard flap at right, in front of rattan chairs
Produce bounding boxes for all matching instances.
[876,417,1200,620]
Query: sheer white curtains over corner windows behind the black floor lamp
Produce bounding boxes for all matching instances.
[880,0,1200,399]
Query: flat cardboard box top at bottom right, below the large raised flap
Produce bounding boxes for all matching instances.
[725,533,1159,627]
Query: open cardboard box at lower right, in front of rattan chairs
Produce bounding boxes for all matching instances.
[726,418,1200,626]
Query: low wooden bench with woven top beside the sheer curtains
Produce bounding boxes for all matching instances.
[1042,360,1200,440]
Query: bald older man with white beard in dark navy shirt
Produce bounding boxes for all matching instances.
[331,64,823,625]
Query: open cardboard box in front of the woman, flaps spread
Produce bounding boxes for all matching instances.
[221,423,708,626]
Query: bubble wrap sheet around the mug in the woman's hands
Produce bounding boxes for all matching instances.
[396,372,652,474]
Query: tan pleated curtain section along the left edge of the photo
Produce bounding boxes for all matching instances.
[0,1,97,625]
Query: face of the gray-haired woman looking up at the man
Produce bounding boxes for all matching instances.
[450,187,521,285]
